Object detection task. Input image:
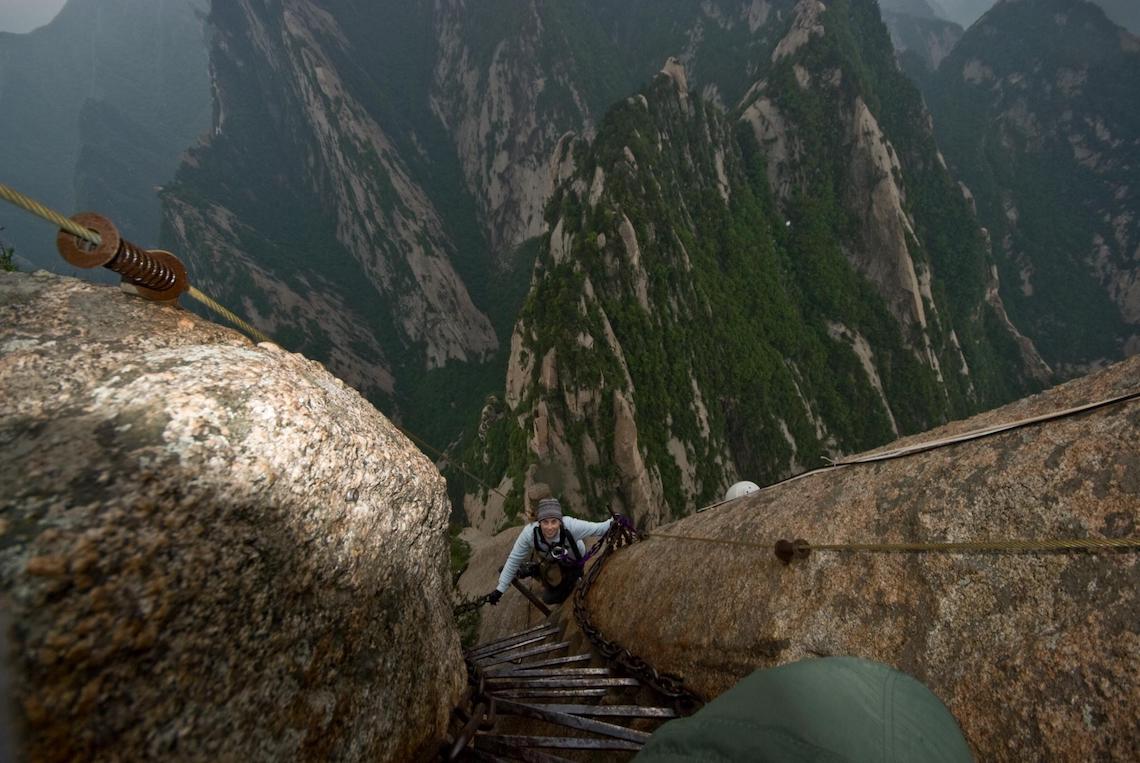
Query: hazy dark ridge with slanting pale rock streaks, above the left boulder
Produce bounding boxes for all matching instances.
[164,1,497,410]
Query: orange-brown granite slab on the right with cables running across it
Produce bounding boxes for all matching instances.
[589,358,1140,760]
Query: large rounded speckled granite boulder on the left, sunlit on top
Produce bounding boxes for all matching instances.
[0,274,463,761]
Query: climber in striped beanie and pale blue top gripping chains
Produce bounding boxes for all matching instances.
[487,498,613,604]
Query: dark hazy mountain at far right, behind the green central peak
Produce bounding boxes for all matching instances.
[919,0,1140,376]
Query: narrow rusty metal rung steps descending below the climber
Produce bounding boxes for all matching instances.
[442,624,678,762]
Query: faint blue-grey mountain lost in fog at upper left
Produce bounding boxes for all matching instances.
[0,0,211,277]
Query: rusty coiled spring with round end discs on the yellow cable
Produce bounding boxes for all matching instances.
[56,212,190,302]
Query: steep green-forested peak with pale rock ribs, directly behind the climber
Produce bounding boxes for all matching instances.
[466,2,1048,530]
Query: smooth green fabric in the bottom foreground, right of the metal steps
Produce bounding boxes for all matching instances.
[636,657,972,763]
